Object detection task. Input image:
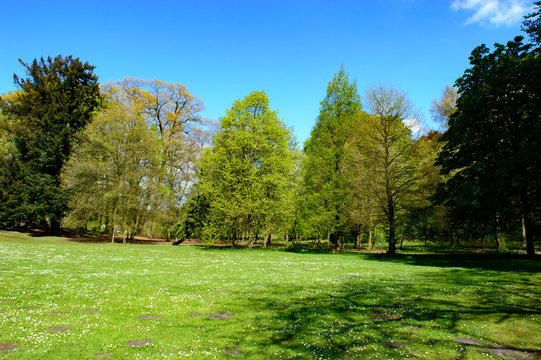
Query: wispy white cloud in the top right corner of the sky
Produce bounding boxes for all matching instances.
[451,0,531,26]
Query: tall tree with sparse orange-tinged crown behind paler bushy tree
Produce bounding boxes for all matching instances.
[104,78,209,237]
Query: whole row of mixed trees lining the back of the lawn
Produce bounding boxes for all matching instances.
[0,2,541,255]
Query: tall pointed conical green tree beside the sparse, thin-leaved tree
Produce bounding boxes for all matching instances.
[304,67,361,251]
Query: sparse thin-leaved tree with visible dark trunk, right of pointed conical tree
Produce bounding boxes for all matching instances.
[353,85,417,254]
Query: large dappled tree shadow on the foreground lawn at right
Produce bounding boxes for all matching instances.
[221,269,541,359]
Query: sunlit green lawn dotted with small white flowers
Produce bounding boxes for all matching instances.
[0,232,541,359]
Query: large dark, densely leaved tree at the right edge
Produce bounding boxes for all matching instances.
[437,37,541,256]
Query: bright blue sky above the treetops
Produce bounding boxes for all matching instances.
[0,0,532,142]
